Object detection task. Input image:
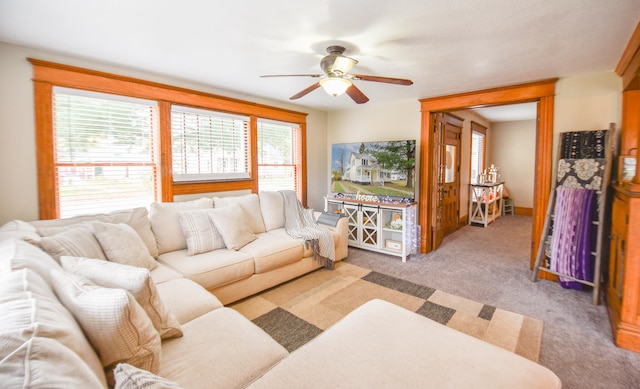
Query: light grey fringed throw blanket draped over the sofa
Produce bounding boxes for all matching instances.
[280,190,336,269]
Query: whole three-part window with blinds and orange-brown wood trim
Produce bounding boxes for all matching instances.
[29,58,307,219]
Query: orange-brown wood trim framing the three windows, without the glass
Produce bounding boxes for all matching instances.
[28,58,307,219]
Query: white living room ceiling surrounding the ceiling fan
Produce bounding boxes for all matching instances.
[0,0,640,118]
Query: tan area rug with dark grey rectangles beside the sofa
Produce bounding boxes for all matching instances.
[230,262,543,362]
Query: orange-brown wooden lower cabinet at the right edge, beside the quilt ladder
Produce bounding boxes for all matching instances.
[606,186,640,352]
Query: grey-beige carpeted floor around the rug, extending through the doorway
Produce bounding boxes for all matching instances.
[345,215,640,389]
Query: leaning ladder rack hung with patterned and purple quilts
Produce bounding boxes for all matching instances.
[531,123,615,305]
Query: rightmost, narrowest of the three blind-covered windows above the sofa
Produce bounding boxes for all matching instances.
[258,119,301,191]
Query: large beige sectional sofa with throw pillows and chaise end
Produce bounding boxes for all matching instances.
[0,193,561,388]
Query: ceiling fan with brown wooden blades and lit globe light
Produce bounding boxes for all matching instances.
[260,46,413,104]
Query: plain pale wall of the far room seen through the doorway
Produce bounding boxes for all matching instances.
[487,120,536,208]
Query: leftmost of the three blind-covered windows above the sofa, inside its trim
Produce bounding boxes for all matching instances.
[53,87,158,217]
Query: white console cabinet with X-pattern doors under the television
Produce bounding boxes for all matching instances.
[324,197,419,262]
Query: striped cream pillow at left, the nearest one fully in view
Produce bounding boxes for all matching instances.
[51,269,160,373]
